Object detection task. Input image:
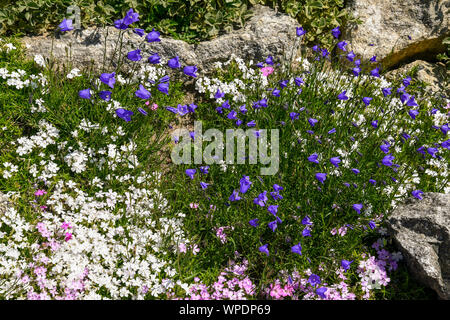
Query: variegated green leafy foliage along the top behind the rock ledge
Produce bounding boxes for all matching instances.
[0,0,355,46]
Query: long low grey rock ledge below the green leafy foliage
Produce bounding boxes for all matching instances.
[23,5,298,75]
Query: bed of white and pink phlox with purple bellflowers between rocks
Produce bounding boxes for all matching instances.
[0,9,450,300]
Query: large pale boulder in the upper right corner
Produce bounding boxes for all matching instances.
[344,0,450,68]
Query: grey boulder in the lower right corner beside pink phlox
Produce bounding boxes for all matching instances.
[388,193,450,300]
